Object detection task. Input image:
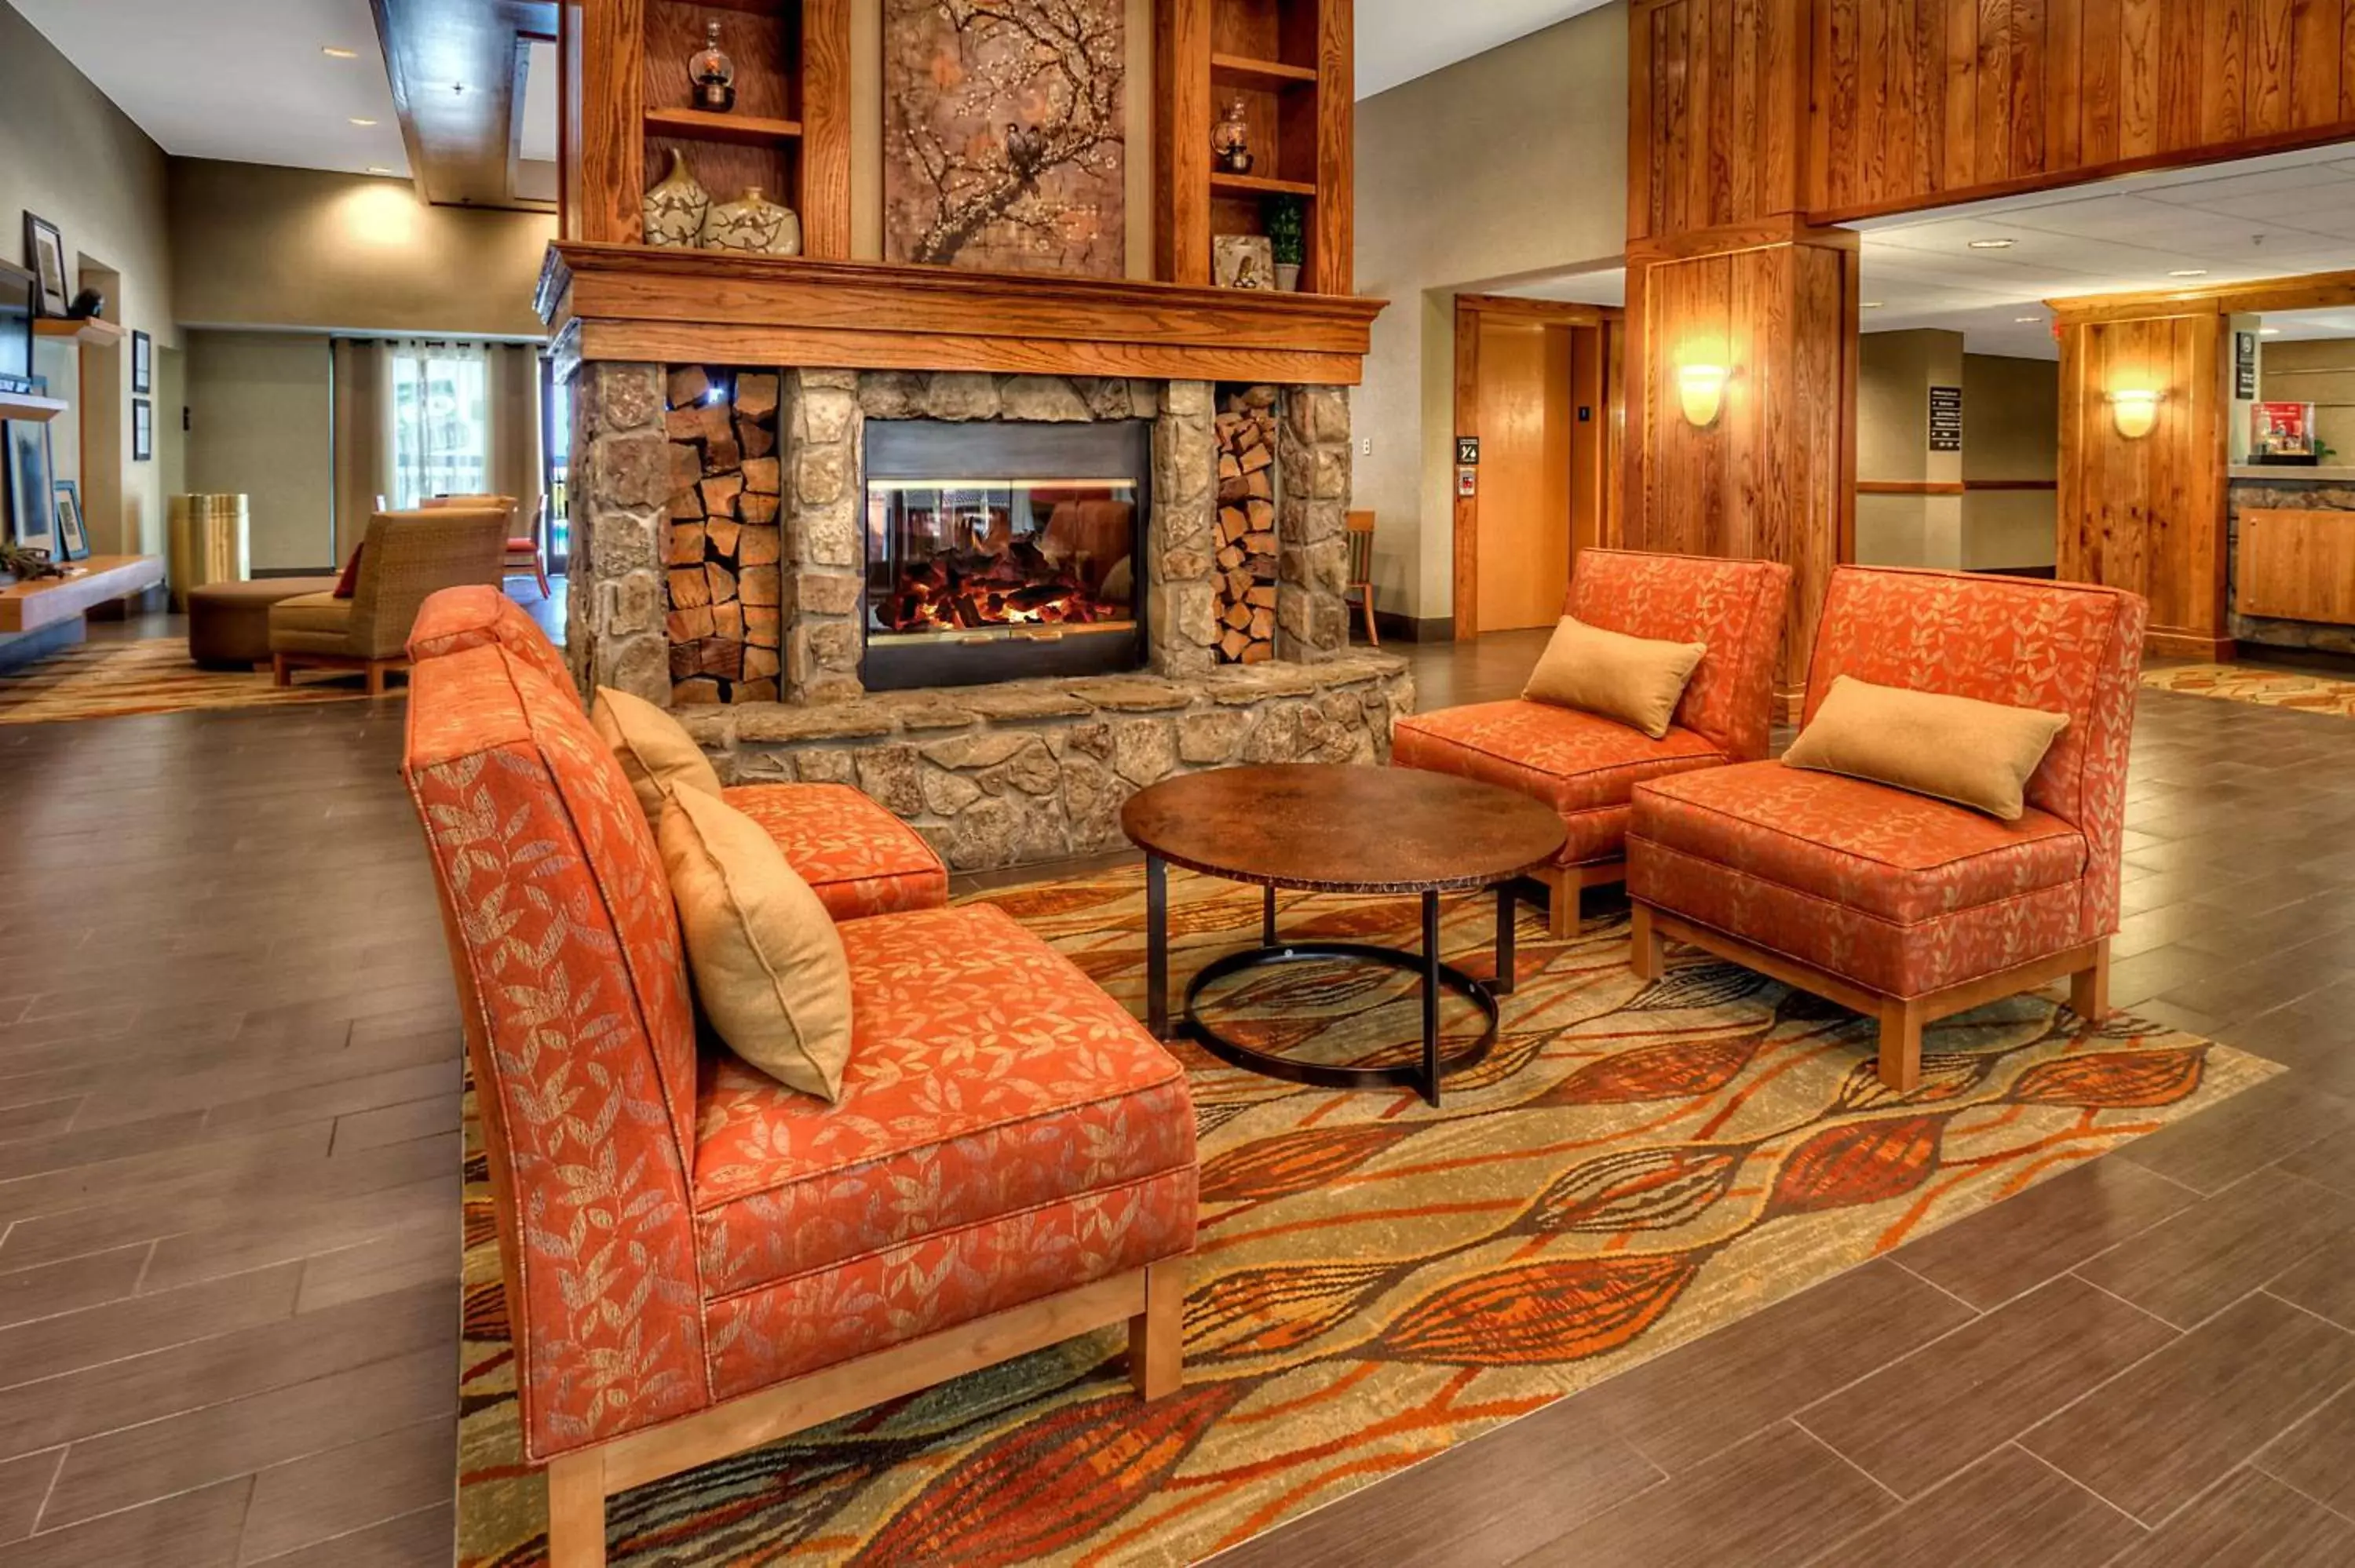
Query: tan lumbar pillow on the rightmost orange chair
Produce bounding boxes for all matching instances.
[1783,676,2068,822]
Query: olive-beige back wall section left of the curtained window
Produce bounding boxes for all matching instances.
[186,330,337,572]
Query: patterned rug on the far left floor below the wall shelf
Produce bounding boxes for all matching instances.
[0,638,403,725]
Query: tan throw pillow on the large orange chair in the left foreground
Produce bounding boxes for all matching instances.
[657,789,850,1099]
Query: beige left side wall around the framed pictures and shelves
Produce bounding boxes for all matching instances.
[0,2,179,553]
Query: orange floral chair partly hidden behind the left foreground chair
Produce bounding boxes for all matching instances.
[410,586,949,921]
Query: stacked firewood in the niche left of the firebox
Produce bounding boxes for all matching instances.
[664,365,784,704]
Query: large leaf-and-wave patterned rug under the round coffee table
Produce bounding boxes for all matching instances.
[459,871,2280,1568]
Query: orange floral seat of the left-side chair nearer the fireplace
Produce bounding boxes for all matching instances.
[721,784,949,921]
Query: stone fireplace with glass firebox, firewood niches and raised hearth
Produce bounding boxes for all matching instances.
[570,360,1413,871]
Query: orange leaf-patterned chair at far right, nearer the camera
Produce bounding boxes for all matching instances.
[1627,567,2145,1090]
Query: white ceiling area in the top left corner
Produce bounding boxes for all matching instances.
[7,0,410,174]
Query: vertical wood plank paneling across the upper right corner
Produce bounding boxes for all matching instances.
[1627,0,2355,238]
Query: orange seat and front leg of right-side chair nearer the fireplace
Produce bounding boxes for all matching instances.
[1389,699,1729,866]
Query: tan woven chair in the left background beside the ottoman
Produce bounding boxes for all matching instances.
[271,506,511,697]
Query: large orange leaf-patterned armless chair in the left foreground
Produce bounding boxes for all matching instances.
[403,643,1196,1568]
